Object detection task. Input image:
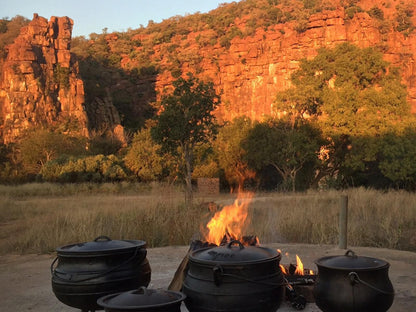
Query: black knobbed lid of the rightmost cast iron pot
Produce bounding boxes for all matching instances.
[315,250,390,270]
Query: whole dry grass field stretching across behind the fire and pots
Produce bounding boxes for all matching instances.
[0,183,416,254]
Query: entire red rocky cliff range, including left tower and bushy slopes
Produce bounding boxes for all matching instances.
[0,0,416,143]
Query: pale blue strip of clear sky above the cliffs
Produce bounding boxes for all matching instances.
[0,0,238,38]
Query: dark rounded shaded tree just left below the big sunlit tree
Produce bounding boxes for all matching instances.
[243,120,322,192]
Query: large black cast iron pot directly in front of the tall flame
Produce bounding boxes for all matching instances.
[182,241,285,312]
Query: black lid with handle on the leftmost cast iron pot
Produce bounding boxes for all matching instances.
[56,236,146,255]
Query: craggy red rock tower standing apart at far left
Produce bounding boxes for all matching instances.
[0,14,88,143]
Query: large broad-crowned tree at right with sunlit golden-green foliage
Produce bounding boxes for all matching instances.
[275,43,411,183]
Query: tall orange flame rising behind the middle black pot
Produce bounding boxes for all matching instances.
[205,193,253,245]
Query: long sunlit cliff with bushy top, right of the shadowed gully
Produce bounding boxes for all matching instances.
[101,0,416,124]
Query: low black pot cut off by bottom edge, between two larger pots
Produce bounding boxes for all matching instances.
[97,287,185,312]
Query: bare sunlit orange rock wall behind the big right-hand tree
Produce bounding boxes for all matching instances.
[149,5,416,120]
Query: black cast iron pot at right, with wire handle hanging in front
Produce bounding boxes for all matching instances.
[314,250,394,312]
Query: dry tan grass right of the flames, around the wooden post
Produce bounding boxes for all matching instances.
[247,188,416,251]
